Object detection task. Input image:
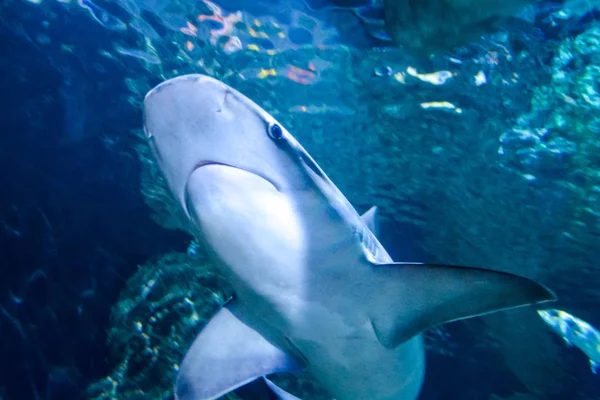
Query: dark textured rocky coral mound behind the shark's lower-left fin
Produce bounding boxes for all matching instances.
[87,253,233,400]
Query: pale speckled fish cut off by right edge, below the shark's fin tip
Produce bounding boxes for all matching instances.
[538,308,600,374]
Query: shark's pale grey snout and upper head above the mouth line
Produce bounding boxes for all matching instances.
[144,75,308,211]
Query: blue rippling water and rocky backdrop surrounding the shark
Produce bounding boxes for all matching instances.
[0,0,600,400]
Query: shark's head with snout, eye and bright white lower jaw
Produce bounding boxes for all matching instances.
[144,75,336,284]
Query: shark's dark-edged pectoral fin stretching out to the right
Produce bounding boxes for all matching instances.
[371,263,556,348]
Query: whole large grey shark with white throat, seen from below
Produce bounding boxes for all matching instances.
[144,75,554,400]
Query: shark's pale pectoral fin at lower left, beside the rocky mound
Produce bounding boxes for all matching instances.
[175,305,301,400]
